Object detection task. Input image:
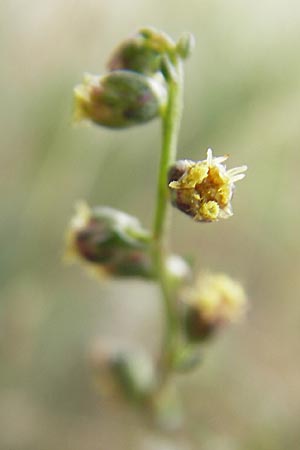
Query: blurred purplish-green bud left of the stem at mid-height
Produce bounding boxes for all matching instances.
[67,204,153,278]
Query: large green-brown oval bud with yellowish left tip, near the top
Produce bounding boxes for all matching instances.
[74,70,166,128]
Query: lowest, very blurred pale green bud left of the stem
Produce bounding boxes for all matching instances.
[90,342,156,403]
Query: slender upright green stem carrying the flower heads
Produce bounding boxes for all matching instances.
[153,58,183,379]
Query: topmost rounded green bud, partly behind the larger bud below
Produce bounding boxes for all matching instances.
[108,28,175,75]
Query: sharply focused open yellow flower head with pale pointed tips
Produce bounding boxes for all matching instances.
[169,149,247,222]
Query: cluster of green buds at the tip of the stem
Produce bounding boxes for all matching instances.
[74,28,193,128]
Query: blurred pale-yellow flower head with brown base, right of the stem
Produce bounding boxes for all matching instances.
[183,274,247,340]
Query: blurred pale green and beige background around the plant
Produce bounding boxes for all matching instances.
[0,0,300,450]
